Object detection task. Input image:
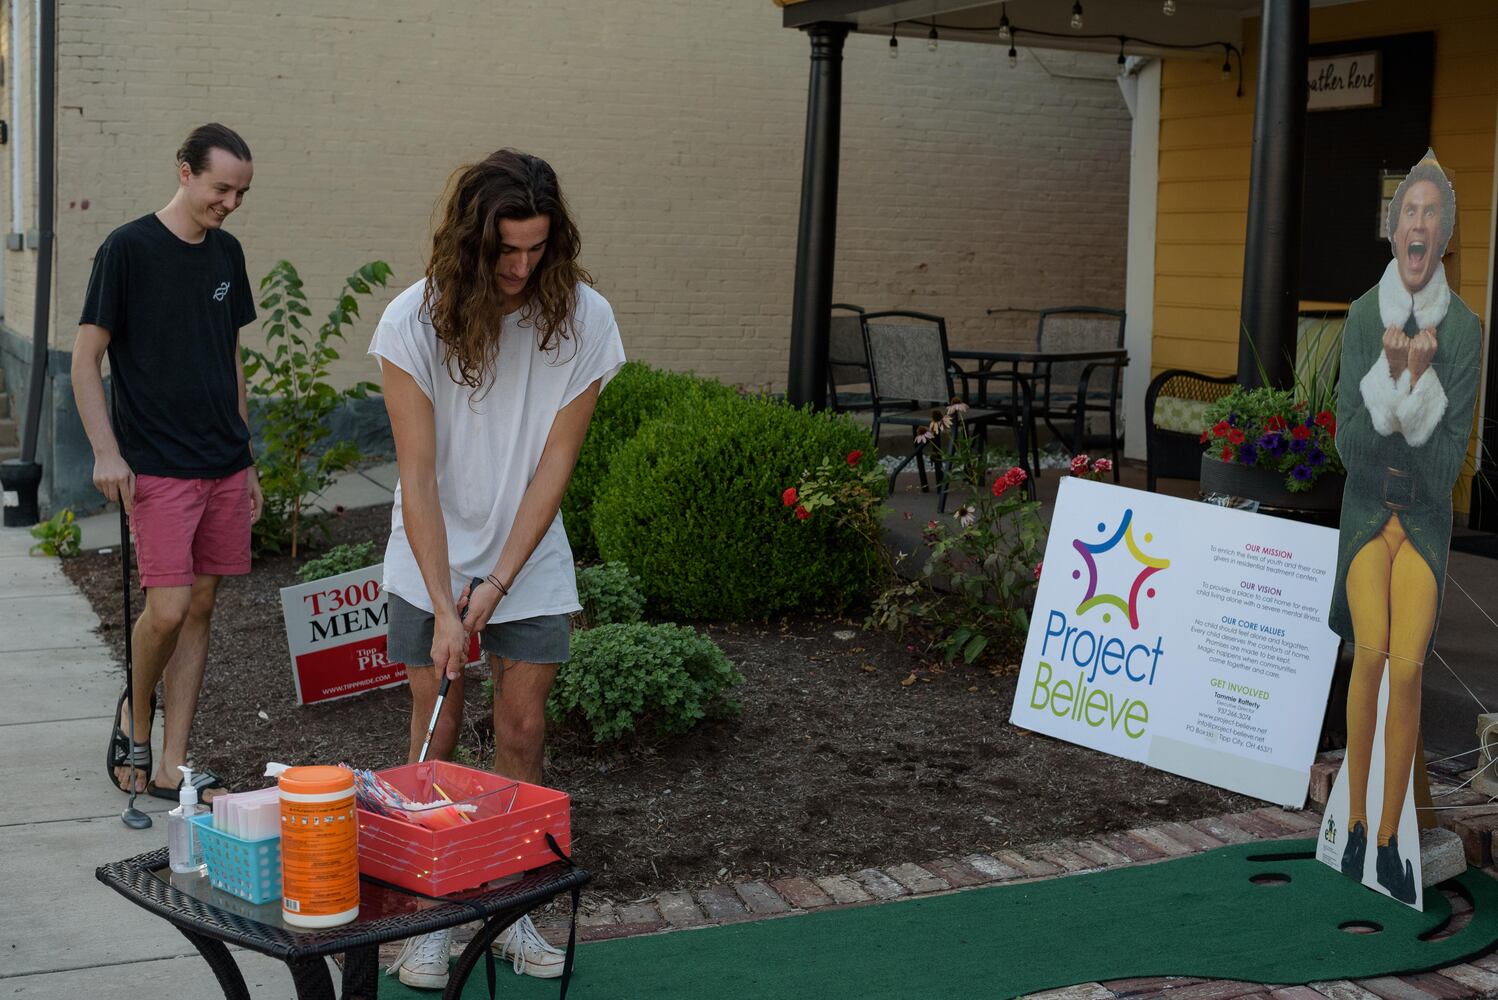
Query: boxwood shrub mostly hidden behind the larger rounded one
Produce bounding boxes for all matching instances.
[562,361,739,558]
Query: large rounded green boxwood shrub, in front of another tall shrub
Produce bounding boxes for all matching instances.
[593,397,879,620]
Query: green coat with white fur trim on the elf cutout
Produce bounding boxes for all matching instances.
[1329,260,1483,656]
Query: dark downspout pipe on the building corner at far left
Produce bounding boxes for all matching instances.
[0,0,57,527]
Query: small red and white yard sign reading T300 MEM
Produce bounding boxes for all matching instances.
[282,563,478,705]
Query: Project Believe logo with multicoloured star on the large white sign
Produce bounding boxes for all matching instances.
[1029,507,1170,740]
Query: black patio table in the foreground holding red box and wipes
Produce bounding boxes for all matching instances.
[96,847,590,1000]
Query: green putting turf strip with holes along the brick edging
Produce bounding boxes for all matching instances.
[380,840,1498,1000]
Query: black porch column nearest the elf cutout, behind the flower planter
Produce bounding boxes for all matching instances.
[1237,0,1311,388]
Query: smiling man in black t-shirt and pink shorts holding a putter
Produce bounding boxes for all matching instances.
[72,124,261,801]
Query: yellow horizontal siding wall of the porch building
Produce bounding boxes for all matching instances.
[1152,0,1498,374]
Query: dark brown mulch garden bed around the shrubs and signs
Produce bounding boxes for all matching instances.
[63,506,1257,900]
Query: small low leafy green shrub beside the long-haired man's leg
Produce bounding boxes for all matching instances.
[547,623,743,744]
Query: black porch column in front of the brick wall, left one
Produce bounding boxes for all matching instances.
[785,21,848,409]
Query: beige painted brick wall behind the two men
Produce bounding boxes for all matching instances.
[23,0,1129,388]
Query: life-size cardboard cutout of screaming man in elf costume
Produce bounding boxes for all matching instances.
[1318,151,1483,909]
